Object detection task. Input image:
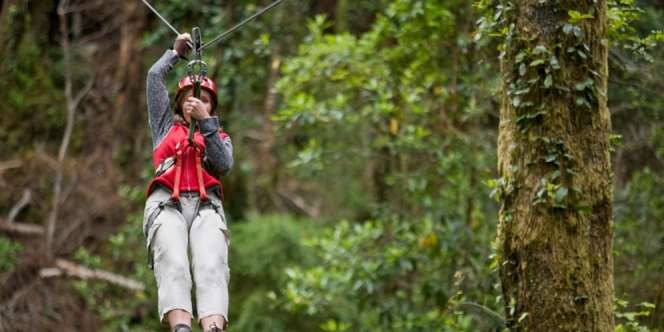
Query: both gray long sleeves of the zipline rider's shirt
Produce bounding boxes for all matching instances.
[147,50,233,175]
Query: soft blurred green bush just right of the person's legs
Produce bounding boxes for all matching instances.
[229,215,320,332]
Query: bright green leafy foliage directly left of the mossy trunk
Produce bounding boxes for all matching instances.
[274,0,495,331]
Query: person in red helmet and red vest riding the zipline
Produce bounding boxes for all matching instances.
[143,34,233,332]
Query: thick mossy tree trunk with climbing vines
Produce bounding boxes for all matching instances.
[496,0,614,332]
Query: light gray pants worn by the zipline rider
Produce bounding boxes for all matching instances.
[143,188,230,326]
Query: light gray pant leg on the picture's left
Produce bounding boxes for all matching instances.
[151,206,193,325]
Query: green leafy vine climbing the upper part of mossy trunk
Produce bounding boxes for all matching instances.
[476,0,607,211]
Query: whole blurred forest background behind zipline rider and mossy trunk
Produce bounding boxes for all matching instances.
[0,0,664,331]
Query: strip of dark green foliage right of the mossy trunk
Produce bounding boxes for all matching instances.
[609,2,664,328]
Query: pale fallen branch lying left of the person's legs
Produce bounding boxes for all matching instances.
[39,259,145,291]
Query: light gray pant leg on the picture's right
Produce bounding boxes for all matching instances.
[189,204,230,324]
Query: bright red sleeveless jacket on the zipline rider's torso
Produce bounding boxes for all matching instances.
[147,123,228,197]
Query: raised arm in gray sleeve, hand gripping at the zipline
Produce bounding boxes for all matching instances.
[146,33,191,148]
